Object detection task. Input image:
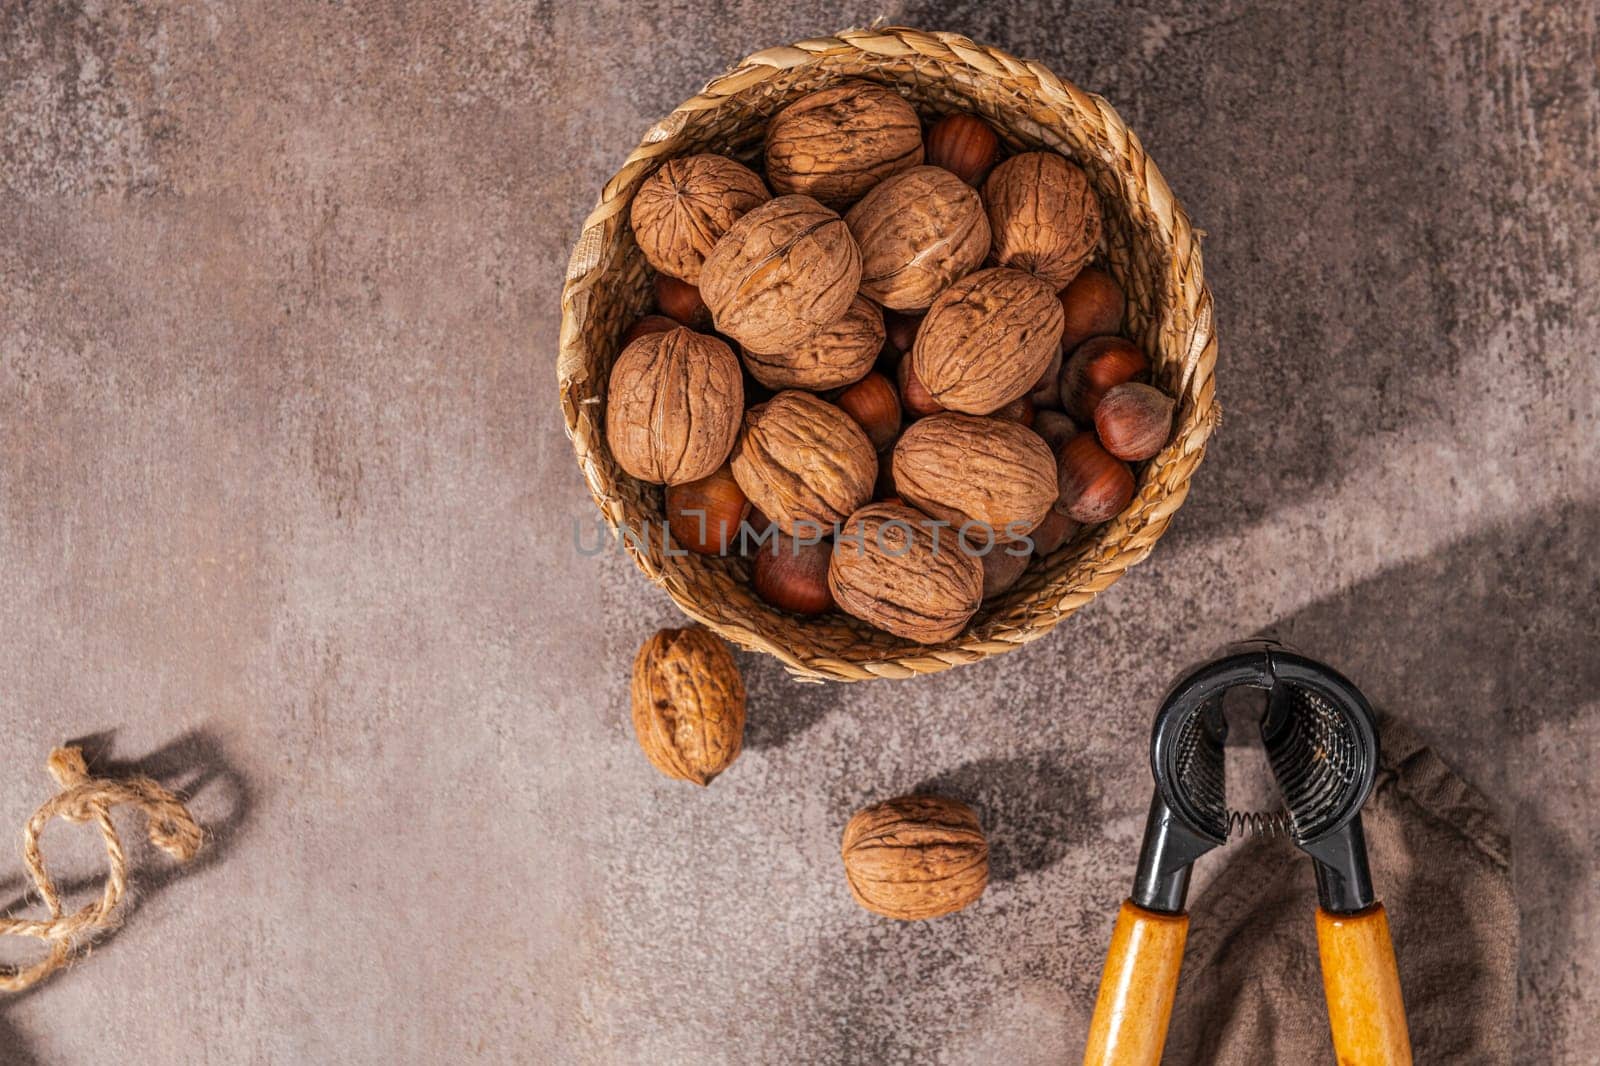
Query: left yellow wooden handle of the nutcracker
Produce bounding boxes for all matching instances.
[1083,900,1189,1066]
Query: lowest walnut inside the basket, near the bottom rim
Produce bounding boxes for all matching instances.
[827,503,984,643]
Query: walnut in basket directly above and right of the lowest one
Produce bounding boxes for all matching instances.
[893,411,1058,534]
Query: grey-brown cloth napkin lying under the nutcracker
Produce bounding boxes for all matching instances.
[1163,715,1517,1066]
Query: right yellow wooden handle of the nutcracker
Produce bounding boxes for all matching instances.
[1317,903,1411,1066]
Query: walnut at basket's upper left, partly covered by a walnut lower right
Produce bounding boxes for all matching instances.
[629,155,771,285]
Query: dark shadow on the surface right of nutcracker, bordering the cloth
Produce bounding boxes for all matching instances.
[1262,501,1600,1048]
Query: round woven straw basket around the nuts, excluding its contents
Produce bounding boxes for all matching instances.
[557,27,1221,680]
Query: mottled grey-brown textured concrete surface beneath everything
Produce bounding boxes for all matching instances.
[0,0,1600,1066]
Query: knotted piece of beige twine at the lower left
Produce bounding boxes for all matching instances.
[0,747,205,992]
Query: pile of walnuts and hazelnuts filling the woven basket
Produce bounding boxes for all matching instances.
[606,82,1174,643]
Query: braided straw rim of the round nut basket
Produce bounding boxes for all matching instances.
[557,26,1221,680]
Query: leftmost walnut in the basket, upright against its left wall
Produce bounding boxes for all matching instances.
[605,327,744,485]
